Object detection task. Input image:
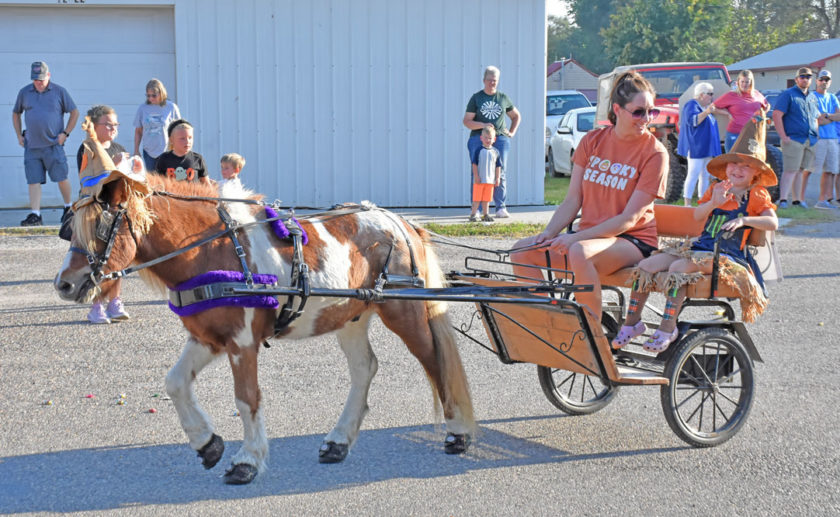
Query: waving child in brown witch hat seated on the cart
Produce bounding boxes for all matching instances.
[612,112,779,354]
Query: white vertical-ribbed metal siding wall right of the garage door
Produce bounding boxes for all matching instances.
[175,0,545,206]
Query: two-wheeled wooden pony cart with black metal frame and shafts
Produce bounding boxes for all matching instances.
[450,205,771,447]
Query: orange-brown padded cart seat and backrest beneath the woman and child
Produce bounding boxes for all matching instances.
[600,205,767,298]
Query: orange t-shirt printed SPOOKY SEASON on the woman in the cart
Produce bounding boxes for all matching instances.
[574,127,668,246]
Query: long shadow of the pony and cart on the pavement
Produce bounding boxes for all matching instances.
[0,415,684,514]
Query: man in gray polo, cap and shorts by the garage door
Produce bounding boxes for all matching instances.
[12,61,79,226]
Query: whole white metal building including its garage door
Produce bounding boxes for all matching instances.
[0,0,546,208]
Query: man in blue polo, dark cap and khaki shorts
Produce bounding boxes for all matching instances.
[773,67,819,208]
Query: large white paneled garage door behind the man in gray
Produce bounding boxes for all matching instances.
[0,4,177,208]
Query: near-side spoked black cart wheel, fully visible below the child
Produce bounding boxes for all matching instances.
[660,328,754,447]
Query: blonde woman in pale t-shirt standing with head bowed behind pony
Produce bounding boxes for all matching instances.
[134,79,181,171]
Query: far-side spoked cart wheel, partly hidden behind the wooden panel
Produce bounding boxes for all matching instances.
[537,313,619,415]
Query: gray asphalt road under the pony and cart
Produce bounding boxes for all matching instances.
[0,208,840,517]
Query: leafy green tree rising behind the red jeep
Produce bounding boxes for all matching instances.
[601,0,732,64]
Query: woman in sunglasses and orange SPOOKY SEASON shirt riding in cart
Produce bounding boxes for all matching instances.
[511,72,668,321]
